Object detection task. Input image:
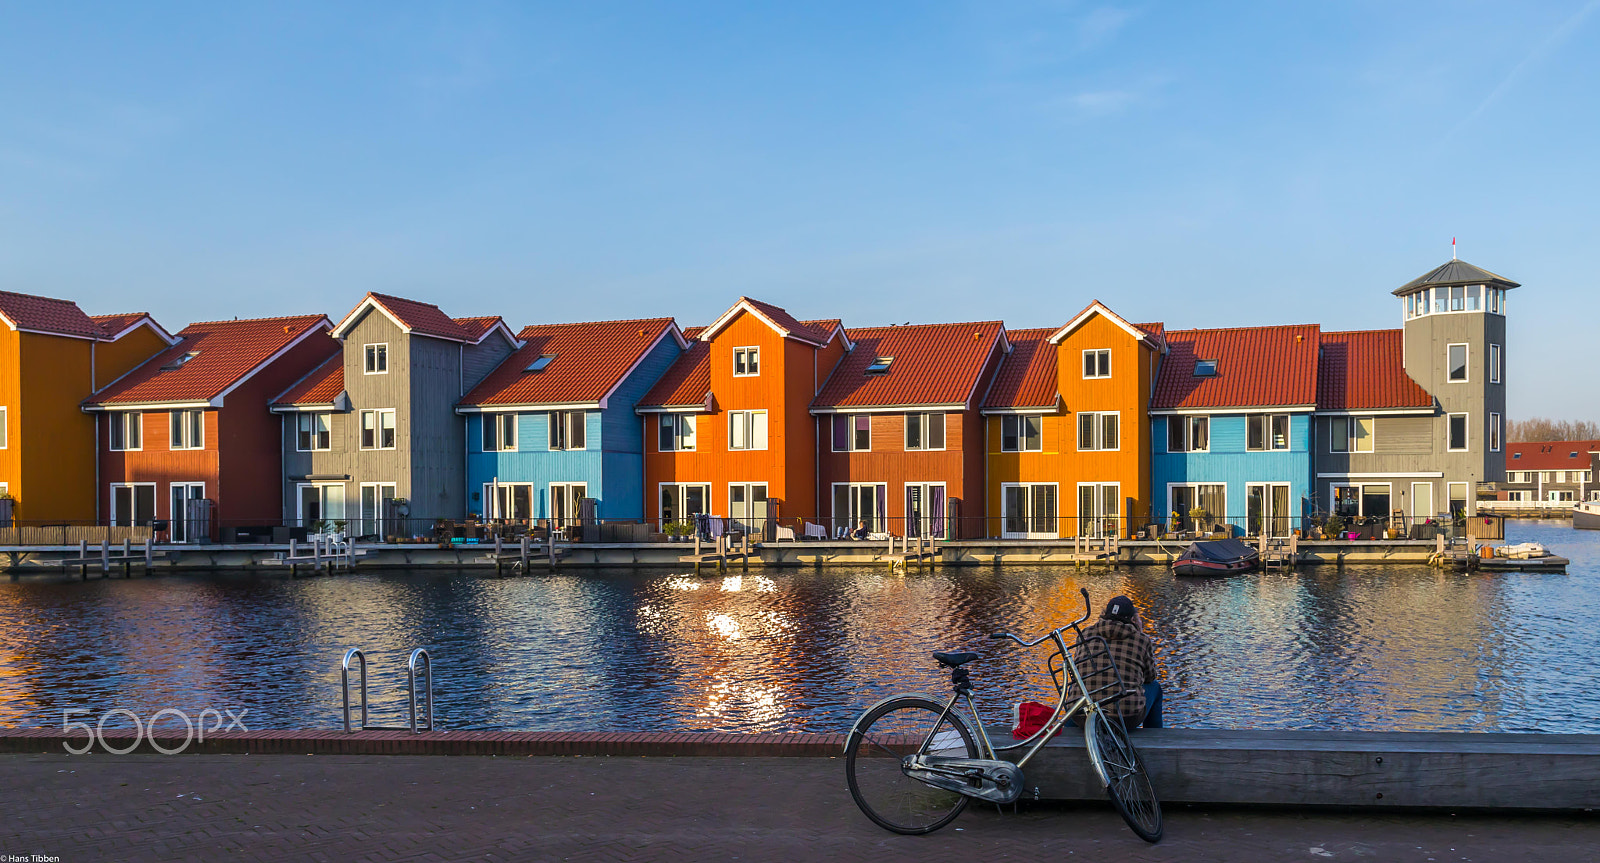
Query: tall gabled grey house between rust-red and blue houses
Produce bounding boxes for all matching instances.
[272,293,518,536]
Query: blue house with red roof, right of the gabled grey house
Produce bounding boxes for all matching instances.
[456,317,688,525]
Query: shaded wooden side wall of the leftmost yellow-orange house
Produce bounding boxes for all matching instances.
[6,333,94,522]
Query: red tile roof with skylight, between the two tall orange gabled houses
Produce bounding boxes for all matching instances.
[811,320,1005,408]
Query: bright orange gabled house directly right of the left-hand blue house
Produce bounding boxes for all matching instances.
[635,296,850,536]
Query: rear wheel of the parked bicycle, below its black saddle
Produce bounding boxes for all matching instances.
[845,696,978,834]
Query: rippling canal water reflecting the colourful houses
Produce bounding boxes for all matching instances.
[0,522,1600,733]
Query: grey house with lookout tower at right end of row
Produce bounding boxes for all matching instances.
[1314,261,1518,527]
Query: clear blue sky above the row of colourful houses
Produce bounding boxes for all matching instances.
[0,0,1600,419]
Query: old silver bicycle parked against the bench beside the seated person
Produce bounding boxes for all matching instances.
[845,588,1162,842]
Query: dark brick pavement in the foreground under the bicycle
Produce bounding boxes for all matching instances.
[0,754,1600,863]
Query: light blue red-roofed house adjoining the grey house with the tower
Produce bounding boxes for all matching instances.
[1150,323,1326,536]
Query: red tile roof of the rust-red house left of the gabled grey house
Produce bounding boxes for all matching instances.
[85,315,336,405]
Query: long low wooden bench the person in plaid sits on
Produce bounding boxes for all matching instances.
[989,725,1600,810]
